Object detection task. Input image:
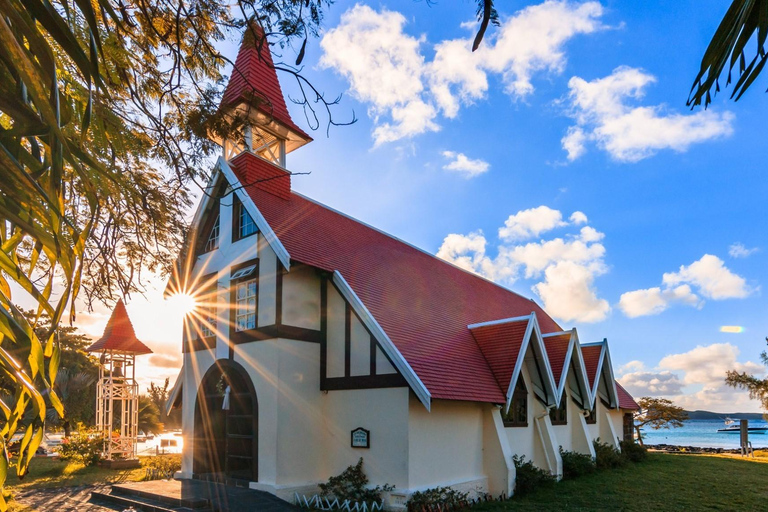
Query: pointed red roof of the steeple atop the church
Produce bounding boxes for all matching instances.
[221,27,312,140]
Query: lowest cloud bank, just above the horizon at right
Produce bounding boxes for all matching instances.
[618,343,765,412]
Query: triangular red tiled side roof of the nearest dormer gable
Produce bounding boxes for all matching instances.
[470,317,530,393]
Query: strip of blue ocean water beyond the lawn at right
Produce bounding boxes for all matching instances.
[642,418,768,449]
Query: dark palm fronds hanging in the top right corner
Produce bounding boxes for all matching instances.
[688,0,768,107]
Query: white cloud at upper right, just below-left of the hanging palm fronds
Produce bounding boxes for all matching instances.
[561,67,734,162]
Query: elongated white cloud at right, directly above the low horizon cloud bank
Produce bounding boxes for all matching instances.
[619,254,754,318]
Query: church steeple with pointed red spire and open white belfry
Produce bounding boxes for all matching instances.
[219,23,312,168]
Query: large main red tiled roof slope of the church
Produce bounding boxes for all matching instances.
[243,185,562,403]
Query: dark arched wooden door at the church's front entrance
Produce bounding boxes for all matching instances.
[193,360,259,482]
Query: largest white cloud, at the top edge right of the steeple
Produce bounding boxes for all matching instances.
[320,0,603,145]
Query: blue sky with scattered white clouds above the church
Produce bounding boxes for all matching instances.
[73,1,768,411]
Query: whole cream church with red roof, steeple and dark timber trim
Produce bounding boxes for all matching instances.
[168,27,637,507]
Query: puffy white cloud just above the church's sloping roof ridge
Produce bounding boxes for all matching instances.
[437,206,611,322]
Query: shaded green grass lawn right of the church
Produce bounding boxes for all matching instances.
[473,453,768,512]
